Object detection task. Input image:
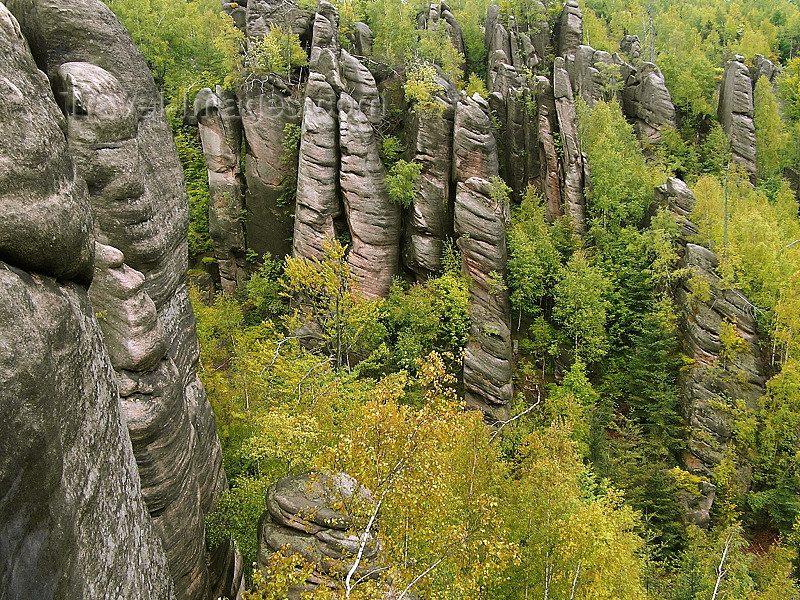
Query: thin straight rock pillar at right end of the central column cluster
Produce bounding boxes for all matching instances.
[553,56,588,234]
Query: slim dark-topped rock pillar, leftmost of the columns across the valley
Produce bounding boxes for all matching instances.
[194,87,247,294]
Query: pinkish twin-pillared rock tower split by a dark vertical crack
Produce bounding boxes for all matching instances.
[294,0,402,298]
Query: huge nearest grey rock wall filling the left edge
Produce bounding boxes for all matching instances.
[0,5,173,600]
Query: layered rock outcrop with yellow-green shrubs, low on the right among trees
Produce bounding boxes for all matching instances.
[656,178,765,527]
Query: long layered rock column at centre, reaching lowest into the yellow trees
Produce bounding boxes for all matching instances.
[453,94,513,420]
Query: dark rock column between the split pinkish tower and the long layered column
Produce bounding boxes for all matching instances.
[403,77,458,281]
